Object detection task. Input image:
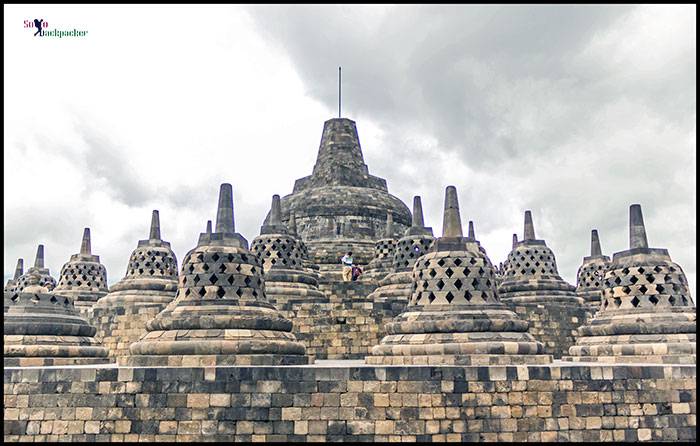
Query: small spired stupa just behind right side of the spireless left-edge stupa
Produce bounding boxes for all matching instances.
[54,228,109,315]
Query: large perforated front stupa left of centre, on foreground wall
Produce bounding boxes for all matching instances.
[126,184,310,366]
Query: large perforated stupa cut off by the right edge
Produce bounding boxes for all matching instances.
[564,204,697,364]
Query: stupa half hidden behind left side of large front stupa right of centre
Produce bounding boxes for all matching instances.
[368,196,435,302]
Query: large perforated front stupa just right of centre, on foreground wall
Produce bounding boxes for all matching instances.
[365,186,551,365]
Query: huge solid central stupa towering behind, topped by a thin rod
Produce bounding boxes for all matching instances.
[264,118,411,269]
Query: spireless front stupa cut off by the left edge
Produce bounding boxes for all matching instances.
[3,269,109,367]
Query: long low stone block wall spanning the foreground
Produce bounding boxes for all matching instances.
[4,364,696,442]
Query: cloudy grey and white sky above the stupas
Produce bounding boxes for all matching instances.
[4,5,697,298]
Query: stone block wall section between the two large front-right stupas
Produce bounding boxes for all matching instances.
[504,302,593,359]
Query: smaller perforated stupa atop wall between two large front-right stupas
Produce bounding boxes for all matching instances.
[499,211,583,304]
